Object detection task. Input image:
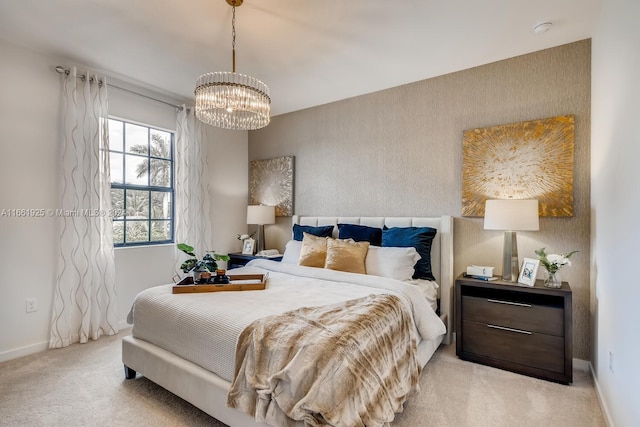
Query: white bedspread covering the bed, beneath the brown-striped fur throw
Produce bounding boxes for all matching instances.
[128,260,445,381]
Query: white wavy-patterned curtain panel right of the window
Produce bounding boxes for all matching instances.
[174,105,213,276]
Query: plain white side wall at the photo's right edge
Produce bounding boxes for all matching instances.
[591,0,640,427]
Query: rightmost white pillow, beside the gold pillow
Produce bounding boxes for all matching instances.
[365,246,421,282]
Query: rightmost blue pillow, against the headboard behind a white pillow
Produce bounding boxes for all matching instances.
[382,227,438,280]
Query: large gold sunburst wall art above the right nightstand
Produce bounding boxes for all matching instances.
[462,115,575,217]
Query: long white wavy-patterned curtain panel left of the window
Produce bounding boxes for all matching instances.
[49,67,118,348]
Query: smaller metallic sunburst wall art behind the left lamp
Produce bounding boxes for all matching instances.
[249,156,293,216]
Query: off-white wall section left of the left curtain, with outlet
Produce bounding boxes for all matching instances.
[0,37,61,361]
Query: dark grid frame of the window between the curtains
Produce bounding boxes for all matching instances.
[108,115,176,248]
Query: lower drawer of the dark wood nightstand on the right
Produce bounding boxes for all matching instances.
[462,321,565,373]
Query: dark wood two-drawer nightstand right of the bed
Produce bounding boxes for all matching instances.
[456,275,573,384]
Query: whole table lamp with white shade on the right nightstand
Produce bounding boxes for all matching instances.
[484,199,540,282]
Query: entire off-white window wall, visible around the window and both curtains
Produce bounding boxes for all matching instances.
[0,40,248,361]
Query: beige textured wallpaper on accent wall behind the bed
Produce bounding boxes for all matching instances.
[249,40,591,360]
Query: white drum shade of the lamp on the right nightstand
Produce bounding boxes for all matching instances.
[484,199,540,231]
